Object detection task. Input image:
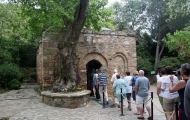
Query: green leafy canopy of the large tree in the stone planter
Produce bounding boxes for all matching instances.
[8,0,113,35]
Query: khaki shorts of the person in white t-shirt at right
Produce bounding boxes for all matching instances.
[163,97,179,112]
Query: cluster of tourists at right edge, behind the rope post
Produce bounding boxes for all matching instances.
[157,63,190,120]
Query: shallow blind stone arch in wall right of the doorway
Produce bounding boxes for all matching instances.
[110,52,128,74]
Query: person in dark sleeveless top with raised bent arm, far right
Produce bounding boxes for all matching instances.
[169,63,190,120]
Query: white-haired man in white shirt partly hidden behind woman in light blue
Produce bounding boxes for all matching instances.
[110,69,118,107]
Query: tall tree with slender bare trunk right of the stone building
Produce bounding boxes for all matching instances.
[147,0,190,72]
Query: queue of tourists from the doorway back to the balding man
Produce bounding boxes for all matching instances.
[90,67,151,119]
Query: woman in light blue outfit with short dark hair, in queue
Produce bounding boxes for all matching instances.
[113,74,126,110]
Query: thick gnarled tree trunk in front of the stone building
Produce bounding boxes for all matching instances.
[54,0,89,88]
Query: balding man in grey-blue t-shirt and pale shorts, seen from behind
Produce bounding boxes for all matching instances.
[135,70,151,120]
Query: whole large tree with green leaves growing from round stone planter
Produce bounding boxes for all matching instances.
[8,0,112,88]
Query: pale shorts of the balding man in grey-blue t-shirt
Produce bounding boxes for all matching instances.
[136,95,150,108]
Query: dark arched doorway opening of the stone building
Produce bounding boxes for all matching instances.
[86,60,102,95]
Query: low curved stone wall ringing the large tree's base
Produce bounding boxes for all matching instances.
[41,90,91,109]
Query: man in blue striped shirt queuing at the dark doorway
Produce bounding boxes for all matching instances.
[98,67,108,104]
